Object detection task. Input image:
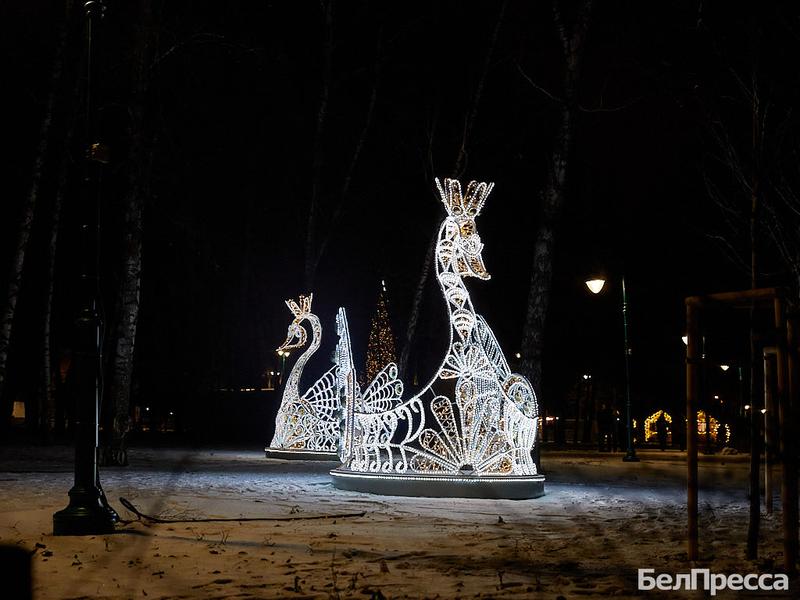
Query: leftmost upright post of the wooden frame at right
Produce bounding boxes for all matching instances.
[686,298,700,560]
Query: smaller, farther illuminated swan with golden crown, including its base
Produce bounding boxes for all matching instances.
[265,294,340,460]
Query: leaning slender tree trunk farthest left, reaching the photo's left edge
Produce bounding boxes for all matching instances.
[0,2,71,429]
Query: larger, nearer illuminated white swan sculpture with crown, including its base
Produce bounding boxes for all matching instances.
[331,179,544,498]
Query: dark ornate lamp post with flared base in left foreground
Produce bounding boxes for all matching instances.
[53,0,119,535]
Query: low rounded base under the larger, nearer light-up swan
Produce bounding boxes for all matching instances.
[331,468,544,500]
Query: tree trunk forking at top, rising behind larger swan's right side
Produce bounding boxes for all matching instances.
[521,0,592,389]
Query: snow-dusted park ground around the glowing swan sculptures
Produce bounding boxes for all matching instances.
[0,447,797,600]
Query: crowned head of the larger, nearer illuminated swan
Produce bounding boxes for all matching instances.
[436,179,494,279]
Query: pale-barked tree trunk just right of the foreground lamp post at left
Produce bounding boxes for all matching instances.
[101,0,156,466]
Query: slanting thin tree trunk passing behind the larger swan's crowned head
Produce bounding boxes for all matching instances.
[398,0,508,378]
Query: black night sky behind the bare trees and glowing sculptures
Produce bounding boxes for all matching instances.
[0,0,800,428]
